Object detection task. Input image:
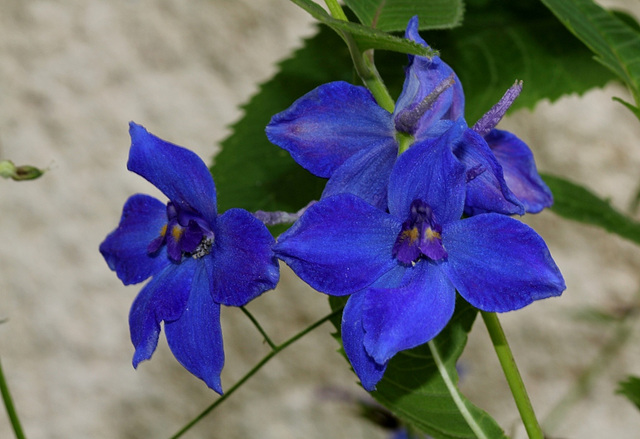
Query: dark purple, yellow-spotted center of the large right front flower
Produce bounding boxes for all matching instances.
[392,199,447,264]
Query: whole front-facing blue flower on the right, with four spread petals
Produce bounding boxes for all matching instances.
[274,132,565,390]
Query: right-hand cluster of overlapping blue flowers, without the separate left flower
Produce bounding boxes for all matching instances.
[267,18,565,390]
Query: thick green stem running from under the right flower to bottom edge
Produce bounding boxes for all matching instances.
[480,311,544,439]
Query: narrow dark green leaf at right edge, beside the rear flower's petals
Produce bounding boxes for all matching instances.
[542,174,640,248]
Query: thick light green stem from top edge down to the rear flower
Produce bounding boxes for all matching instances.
[325,0,395,113]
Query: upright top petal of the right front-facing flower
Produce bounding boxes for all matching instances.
[389,125,465,224]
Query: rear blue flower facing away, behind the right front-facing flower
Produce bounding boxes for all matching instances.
[266,17,552,214]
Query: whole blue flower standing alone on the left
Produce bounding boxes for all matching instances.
[100,122,279,393]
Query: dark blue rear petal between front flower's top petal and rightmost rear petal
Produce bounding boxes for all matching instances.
[453,129,524,215]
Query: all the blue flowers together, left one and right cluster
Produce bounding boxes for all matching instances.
[100,18,565,393]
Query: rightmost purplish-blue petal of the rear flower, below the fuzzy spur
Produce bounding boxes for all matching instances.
[485,130,553,213]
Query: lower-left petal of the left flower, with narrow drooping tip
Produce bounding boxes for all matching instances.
[129,261,196,367]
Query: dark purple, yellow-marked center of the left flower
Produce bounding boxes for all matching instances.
[147,202,214,262]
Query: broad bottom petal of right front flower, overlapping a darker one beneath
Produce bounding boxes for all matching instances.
[362,260,456,363]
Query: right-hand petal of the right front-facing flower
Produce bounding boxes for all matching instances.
[441,213,565,312]
